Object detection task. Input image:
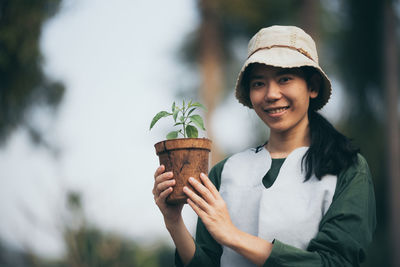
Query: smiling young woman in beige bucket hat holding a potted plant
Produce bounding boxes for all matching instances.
[153,26,376,267]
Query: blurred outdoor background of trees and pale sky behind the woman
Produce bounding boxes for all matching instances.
[0,0,400,266]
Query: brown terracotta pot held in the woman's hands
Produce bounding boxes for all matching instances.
[154,138,211,205]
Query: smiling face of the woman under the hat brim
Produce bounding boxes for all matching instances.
[248,64,318,134]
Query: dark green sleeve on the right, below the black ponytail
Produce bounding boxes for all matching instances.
[263,155,376,267]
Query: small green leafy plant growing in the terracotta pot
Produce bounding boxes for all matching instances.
[150,100,207,139]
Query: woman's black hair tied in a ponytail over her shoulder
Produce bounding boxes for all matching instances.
[301,66,359,181]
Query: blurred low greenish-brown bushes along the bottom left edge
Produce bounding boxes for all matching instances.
[0,191,174,267]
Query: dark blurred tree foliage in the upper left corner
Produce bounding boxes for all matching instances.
[0,0,64,145]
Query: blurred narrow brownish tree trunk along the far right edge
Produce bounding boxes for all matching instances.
[384,0,400,266]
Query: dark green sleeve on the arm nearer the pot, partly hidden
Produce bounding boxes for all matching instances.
[175,159,227,267]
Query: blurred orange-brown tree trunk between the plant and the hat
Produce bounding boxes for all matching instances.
[199,0,224,165]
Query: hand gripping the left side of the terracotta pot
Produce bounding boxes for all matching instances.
[153,165,183,227]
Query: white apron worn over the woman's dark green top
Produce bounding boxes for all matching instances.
[220,147,337,267]
